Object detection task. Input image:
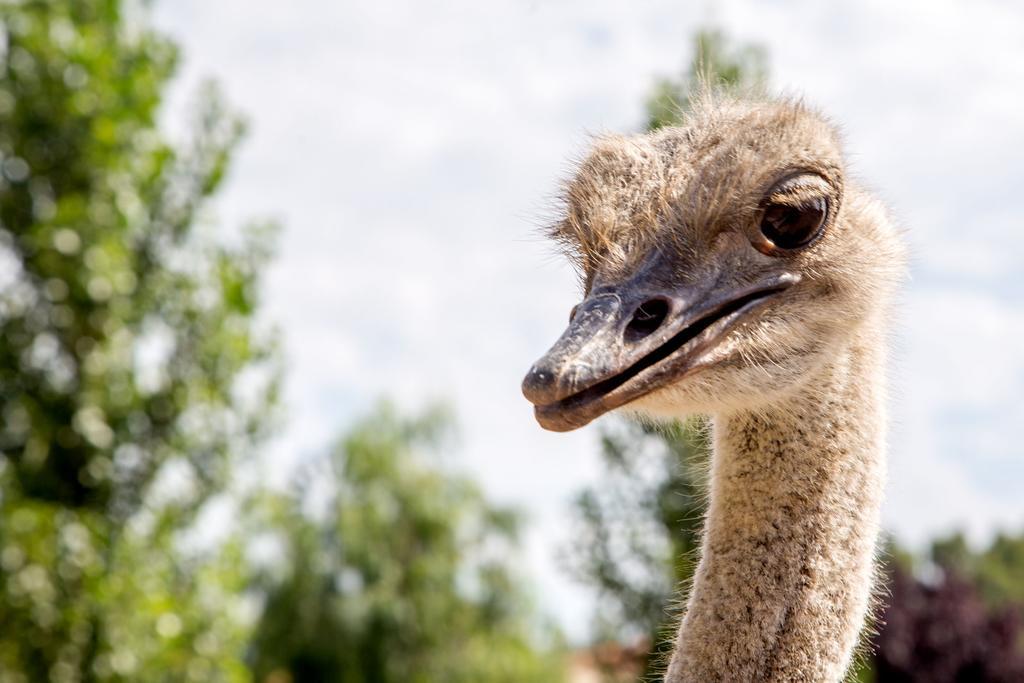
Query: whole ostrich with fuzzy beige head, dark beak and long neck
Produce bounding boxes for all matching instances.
[522,95,903,683]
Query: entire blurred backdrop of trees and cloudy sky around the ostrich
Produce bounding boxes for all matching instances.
[0,0,1024,683]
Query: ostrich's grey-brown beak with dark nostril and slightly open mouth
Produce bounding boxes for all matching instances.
[522,272,798,431]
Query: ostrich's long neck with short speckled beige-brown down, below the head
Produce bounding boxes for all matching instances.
[666,339,885,683]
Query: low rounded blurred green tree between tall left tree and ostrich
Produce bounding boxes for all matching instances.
[251,405,564,683]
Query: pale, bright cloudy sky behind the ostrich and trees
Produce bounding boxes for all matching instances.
[155,0,1024,636]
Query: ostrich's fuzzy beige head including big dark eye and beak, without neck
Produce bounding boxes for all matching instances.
[523,98,901,431]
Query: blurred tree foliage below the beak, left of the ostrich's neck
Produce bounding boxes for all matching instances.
[566,421,709,666]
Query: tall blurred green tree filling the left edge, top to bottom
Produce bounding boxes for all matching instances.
[0,0,276,681]
